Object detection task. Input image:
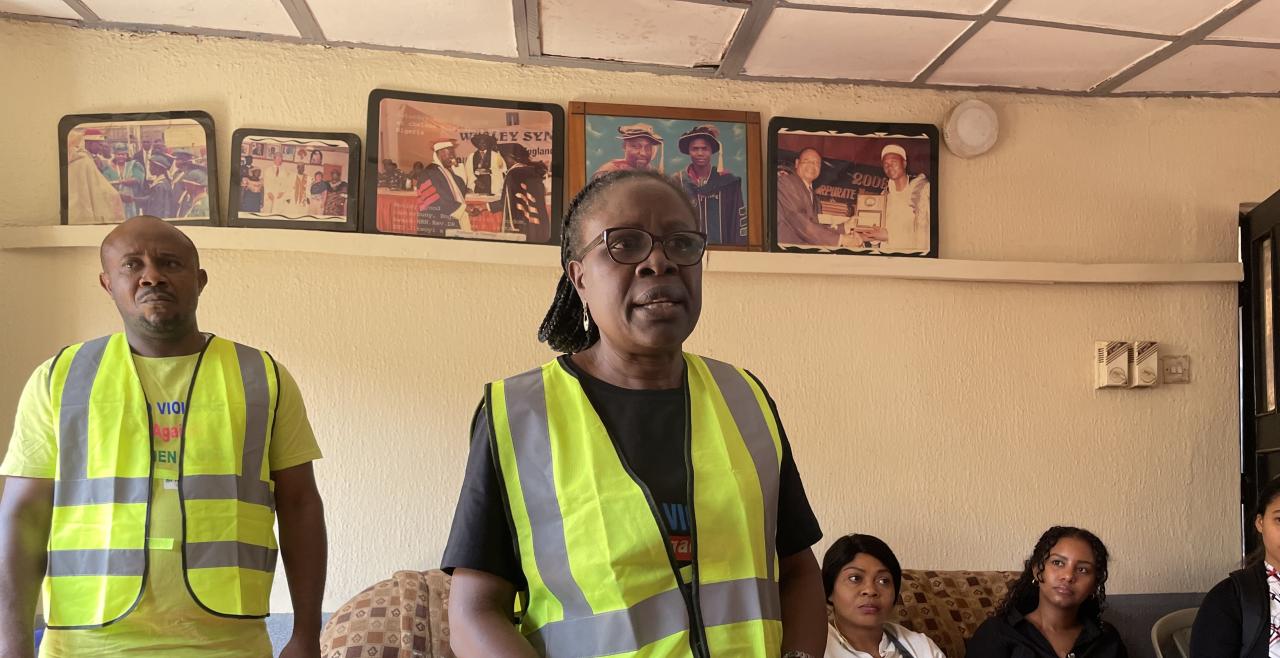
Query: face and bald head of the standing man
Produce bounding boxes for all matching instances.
[99,218,209,337]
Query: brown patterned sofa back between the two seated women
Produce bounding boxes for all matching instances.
[892,568,1019,658]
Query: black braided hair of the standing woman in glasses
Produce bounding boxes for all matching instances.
[538,169,698,355]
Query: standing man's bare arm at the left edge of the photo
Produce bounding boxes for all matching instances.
[0,477,54,658]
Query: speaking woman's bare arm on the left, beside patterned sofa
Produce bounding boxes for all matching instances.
[449,567,538,658]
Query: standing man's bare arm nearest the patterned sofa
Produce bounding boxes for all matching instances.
[271,462,329,658]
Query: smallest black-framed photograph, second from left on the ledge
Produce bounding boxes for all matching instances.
[227,128,360,230]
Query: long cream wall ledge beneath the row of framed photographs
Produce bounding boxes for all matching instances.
[0,225,1244,284]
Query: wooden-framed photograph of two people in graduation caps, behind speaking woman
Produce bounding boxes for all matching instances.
[568,102,764,251]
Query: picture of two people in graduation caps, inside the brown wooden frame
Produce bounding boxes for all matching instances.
[585,114,749,246]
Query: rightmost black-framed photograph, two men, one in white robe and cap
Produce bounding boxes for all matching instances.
[769,116,938,257]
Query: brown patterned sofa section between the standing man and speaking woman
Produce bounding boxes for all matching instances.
[320,570,453,658]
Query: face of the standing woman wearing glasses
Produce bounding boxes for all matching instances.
[568,179,703,353]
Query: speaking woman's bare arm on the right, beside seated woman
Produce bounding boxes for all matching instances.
[778,548,827,658]
